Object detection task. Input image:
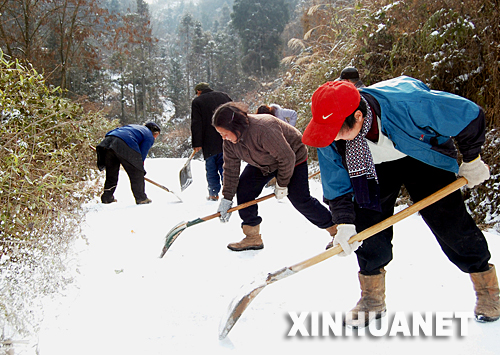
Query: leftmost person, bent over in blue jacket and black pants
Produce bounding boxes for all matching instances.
[96,122,161,205]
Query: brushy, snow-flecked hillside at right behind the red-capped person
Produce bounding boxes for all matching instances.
[267,0,500,229]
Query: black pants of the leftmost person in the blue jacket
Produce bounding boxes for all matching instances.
[101,149,148,203]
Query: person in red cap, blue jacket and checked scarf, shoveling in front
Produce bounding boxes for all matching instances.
[302,76,500,327]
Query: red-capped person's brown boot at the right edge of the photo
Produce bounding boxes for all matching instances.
[470,264,500,322]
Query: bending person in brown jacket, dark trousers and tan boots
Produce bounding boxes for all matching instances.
[213,102,336,251]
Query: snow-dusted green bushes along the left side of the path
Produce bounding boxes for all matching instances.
[0,52,114,331]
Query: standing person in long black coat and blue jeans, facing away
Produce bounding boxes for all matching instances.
[191,83,232,201]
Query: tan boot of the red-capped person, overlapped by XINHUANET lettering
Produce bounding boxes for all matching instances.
[344,269,386,328]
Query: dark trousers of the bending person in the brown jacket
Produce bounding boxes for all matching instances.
[236,162,333,228]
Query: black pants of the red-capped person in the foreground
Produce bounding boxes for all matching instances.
[355,157,490,275]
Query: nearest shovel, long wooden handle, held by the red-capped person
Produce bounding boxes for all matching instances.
[219,177,467,340]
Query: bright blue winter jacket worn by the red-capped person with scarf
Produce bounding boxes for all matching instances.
[318,76,484,200]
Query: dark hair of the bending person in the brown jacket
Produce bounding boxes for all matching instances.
[212,101,248,138]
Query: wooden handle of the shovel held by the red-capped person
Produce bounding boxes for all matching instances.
[290,177,467,272]
